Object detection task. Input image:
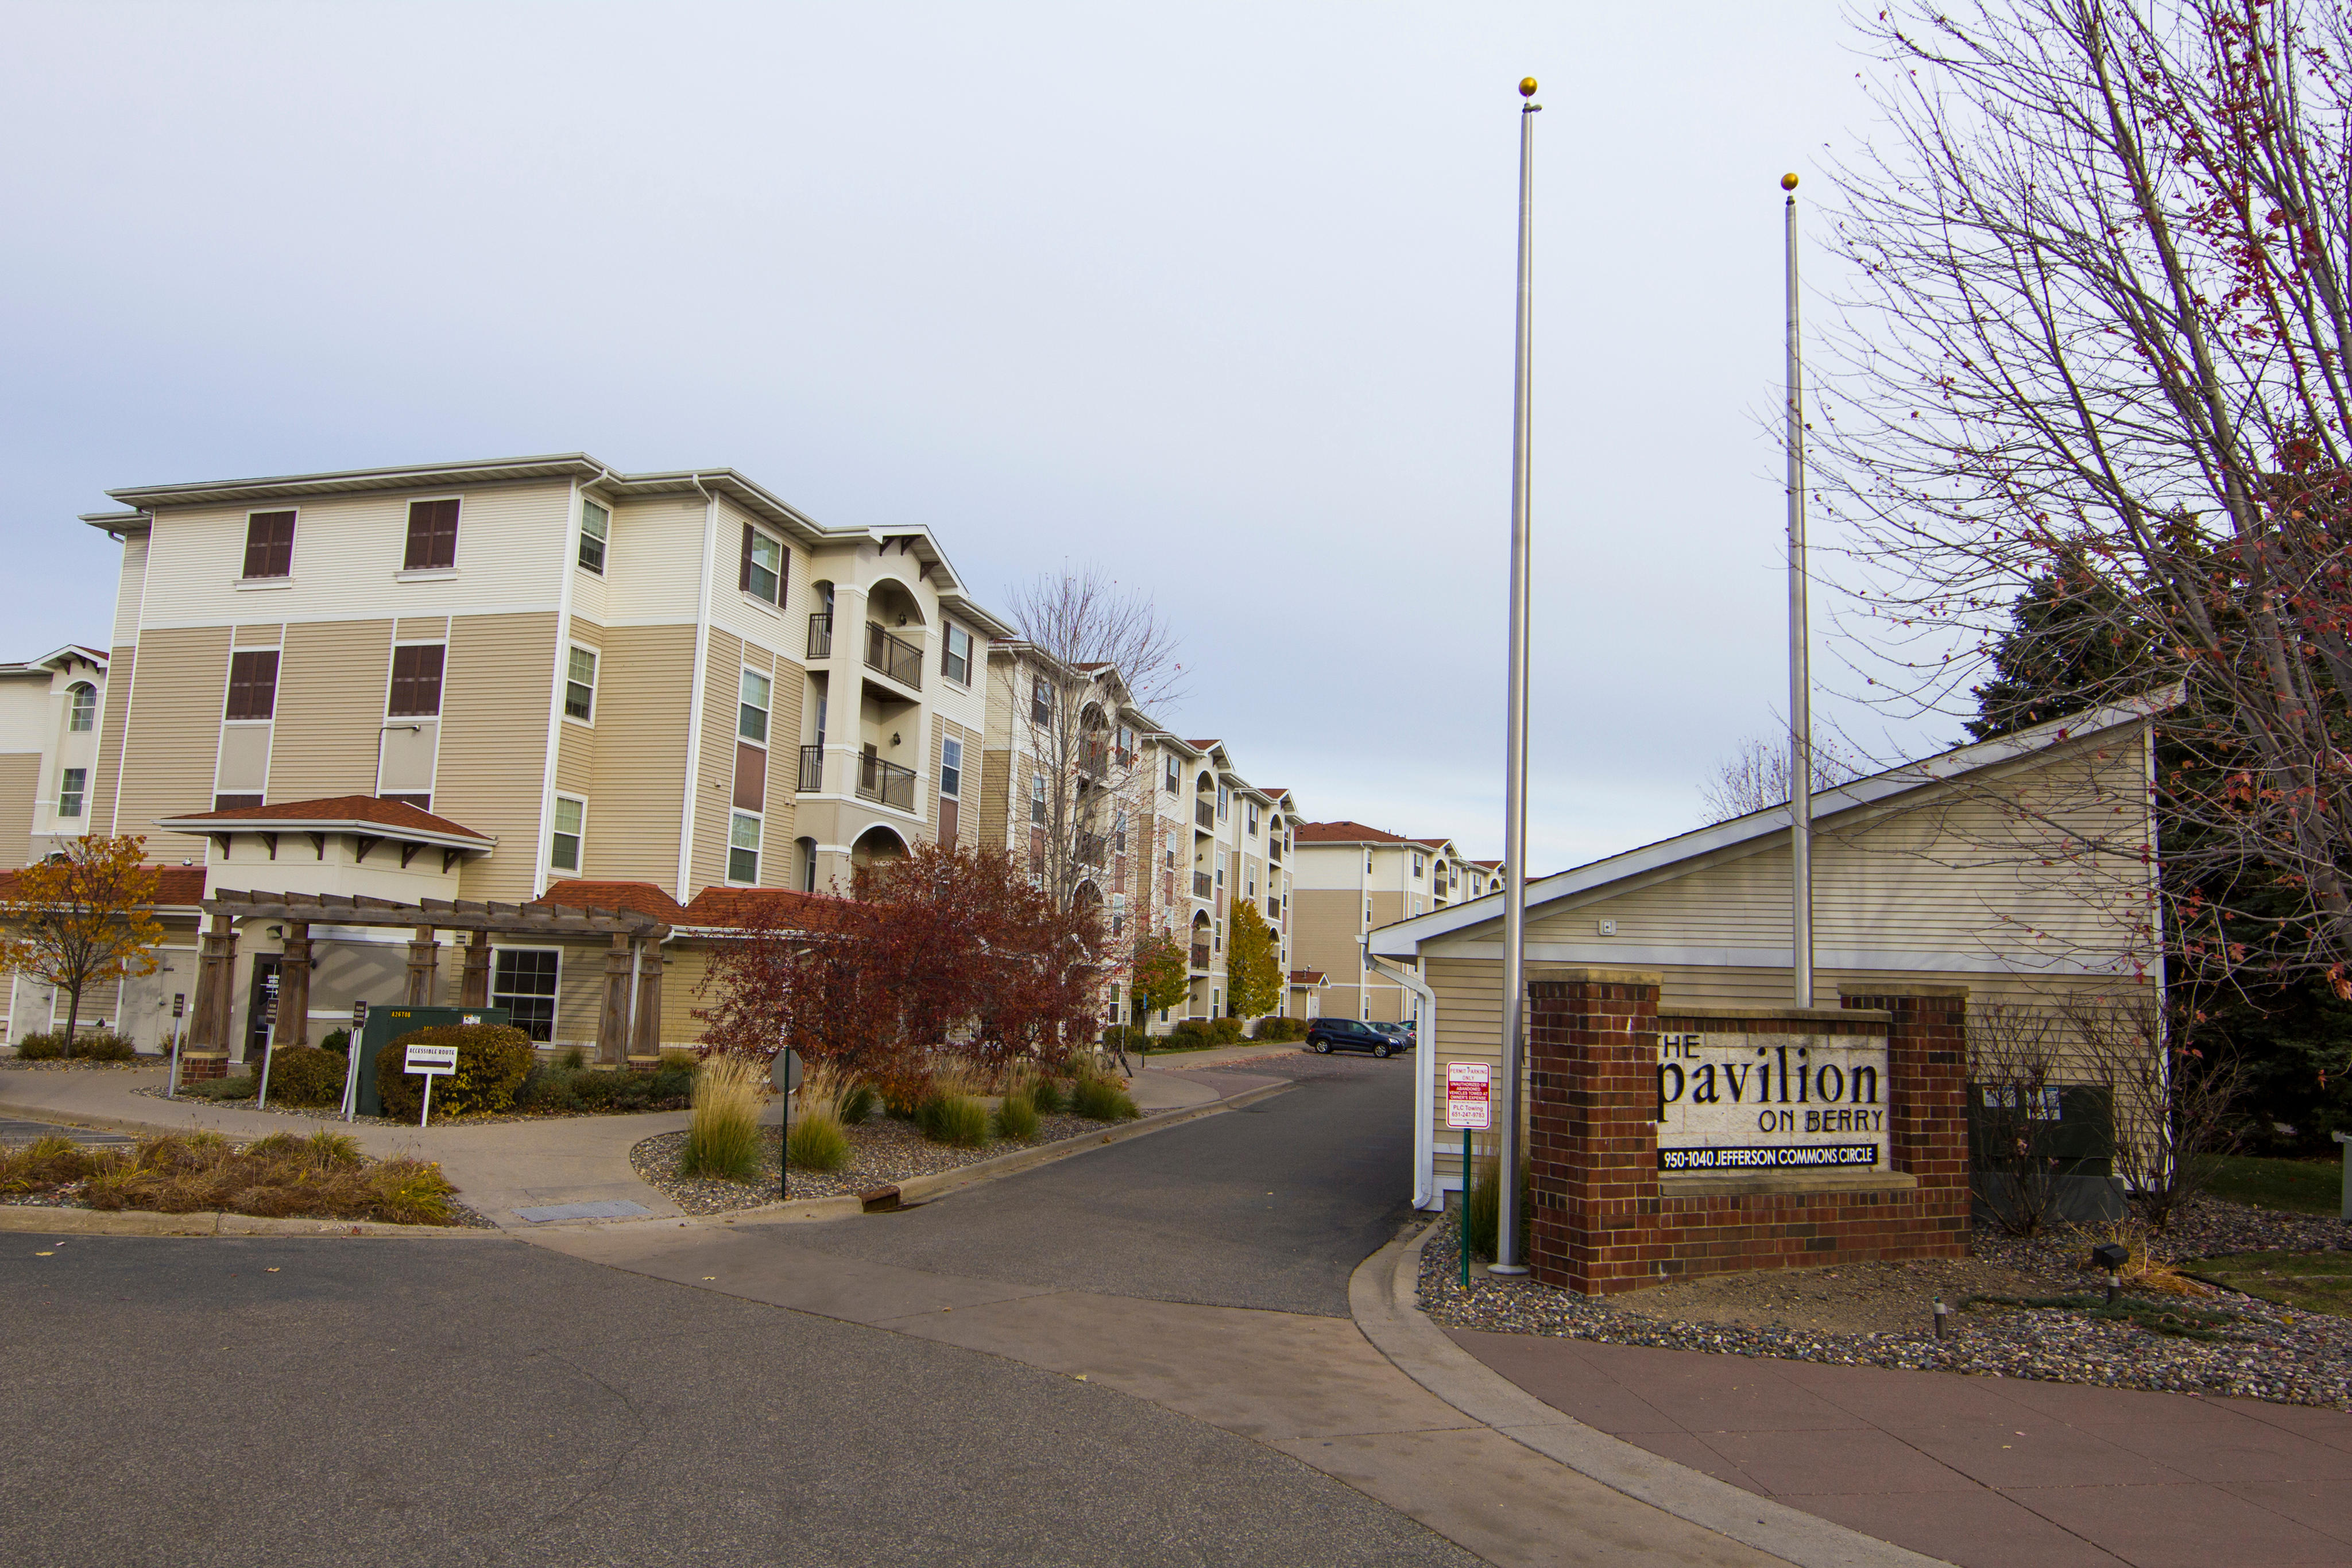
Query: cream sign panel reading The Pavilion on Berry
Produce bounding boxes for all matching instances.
[1658,1035,1886,1173]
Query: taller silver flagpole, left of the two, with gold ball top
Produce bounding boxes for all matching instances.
[1496,78,1543,1274]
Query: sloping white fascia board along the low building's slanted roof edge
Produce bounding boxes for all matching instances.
[1369,684,2180,966]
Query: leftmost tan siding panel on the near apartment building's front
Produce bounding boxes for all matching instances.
[101,625,228,858]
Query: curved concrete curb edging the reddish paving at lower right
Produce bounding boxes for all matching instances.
[1348,1220,1950,1568]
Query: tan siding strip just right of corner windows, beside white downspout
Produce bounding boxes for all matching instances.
[581,625,694,896]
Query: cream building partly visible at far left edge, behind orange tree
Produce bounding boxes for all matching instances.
[0,646,106,870]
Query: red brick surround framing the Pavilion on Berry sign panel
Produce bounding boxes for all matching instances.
[1529,971,1968,1295]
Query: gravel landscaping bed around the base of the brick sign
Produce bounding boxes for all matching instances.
[1421,1201,2352,1411]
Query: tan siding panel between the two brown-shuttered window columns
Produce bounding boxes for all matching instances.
[269,621,393,802]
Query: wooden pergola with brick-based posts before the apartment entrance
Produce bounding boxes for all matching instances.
[188,889,670,1065]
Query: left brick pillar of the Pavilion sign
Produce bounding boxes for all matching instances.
[1526,969,1661,1295]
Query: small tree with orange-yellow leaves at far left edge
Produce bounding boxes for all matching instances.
[0,835,163,1048]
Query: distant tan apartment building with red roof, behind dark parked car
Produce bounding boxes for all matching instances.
[1294,820,1494,1023]
